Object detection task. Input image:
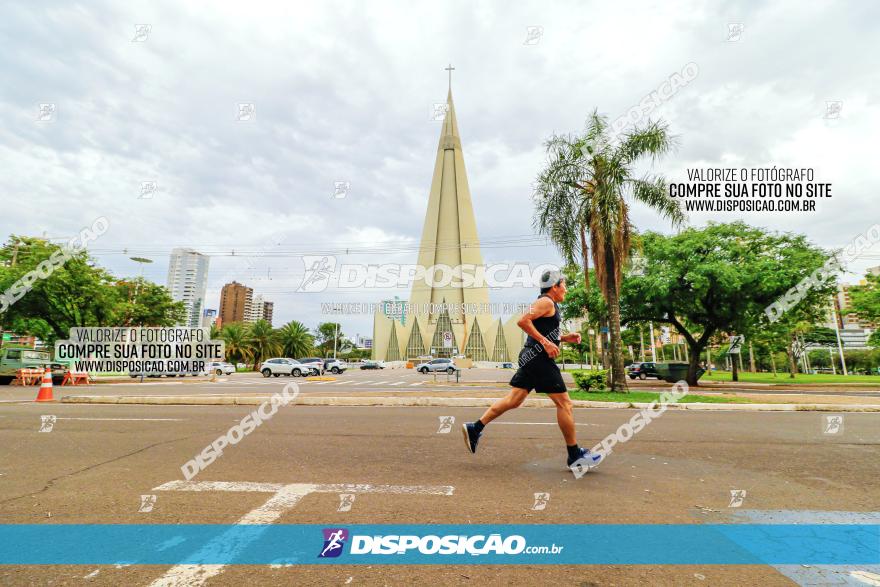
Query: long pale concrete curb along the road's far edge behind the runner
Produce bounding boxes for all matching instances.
[61,395,880,412]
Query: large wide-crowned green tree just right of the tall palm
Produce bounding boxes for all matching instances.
[621,222,835,385]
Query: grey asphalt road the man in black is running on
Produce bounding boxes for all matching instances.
[0,398,880,586]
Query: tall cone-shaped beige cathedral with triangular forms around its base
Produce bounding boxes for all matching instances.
[373,87,524,363]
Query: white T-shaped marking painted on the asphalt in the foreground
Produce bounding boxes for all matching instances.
[150,481,455,587]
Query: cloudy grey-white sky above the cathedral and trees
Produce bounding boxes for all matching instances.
[0,0,880,336]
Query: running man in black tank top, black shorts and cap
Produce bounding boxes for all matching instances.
[461,271,602,467]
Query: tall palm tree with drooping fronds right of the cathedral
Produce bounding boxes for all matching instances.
[535,110,685,391]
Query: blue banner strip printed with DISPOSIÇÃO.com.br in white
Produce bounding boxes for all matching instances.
[0,524,880,565]
